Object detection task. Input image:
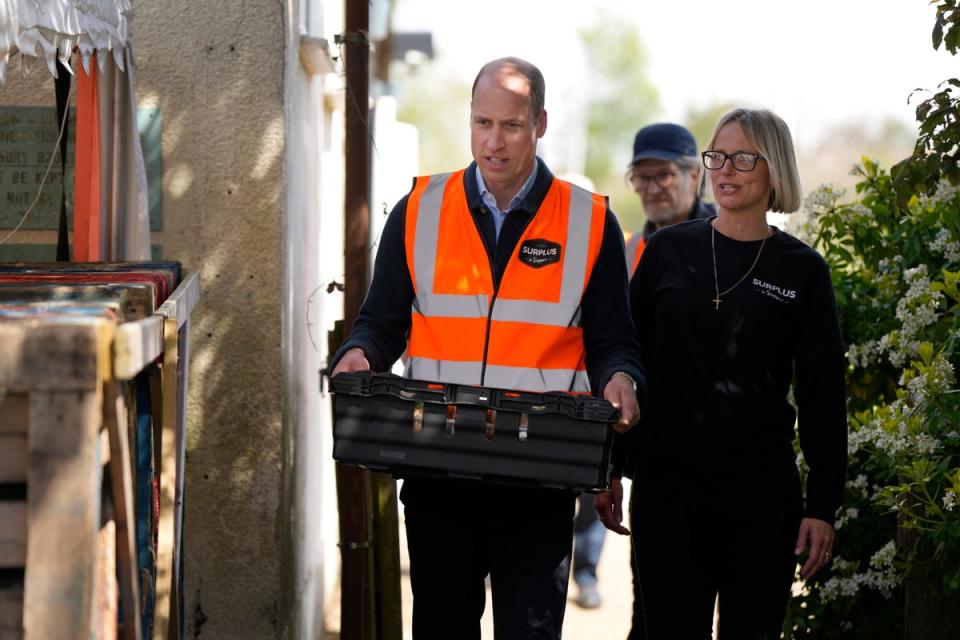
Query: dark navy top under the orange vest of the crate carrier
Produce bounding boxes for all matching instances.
[330,158,646,408]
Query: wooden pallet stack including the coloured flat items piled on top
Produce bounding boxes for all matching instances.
[0,263,199,640]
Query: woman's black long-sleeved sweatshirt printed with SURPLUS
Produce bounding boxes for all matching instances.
[618,218,847,522]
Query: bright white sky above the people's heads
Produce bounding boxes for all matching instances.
[394,0,960,152]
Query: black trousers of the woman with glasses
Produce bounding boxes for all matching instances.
[628,491,802,640]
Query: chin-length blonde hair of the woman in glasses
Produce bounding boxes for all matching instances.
[700,109,803,213]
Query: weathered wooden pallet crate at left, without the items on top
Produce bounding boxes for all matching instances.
[0,275,199,640]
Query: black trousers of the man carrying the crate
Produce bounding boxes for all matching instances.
[400,478,575,640]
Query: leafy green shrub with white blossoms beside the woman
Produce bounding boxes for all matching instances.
[785,0,960,640]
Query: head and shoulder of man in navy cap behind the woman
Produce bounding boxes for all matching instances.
[627,122,716,276]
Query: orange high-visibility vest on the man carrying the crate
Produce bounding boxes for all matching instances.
[404,170,606,392]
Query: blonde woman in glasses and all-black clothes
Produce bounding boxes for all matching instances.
[598,109,847,640]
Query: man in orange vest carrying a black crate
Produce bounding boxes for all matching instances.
[332,58,645,640]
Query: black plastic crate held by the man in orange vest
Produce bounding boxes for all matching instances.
[330,371,617,491]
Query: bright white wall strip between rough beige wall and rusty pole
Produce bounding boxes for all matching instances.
[283,0,344,639]
